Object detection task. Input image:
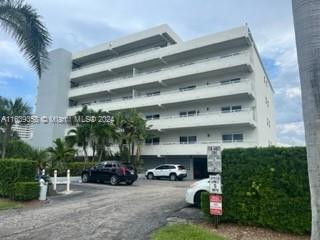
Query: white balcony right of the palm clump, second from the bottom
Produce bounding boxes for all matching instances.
[147,109,256,131]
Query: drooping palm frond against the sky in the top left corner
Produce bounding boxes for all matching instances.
[0,0,51,77]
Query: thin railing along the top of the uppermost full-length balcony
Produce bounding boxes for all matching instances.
[73,51,249,83]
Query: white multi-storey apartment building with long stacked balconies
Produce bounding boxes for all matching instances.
[33,25,276,178]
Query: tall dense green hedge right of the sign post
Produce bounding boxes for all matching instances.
[205,147,311,234]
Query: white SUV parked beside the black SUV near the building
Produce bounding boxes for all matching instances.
[145,164,187,181]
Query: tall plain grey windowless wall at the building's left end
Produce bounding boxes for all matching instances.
[31,49,71,148]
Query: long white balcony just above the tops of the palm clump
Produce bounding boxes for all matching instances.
[67,79,254,116]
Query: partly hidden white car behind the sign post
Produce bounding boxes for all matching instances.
[186,178,209,207]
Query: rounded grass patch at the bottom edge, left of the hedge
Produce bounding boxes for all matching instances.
[151,224,224,240]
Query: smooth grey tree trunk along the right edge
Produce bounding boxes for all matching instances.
[292,0,320,240]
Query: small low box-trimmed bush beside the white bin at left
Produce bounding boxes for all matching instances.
[13,182,40,201]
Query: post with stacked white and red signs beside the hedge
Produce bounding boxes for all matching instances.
[207,146,223,228]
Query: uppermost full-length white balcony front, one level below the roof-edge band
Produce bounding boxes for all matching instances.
[69,51,252,92]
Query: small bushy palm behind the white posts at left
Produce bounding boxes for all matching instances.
[47,138,75,168]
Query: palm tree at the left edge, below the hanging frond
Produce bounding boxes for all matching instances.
[0,97,31,159]
